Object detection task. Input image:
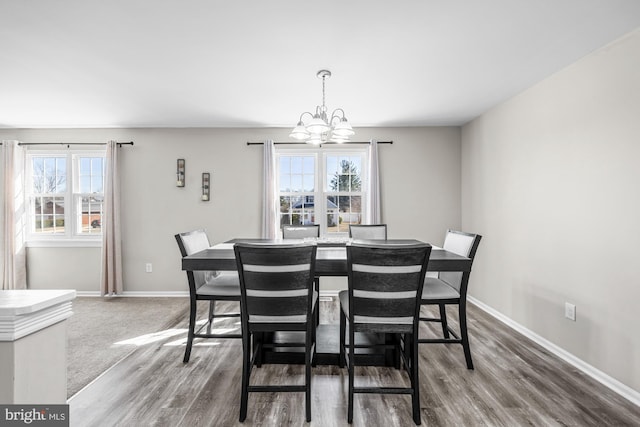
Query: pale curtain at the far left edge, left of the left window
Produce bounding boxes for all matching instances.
[0,141,27,290]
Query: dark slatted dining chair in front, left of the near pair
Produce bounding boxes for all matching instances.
[234,243,318,422]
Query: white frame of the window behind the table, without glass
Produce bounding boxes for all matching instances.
[275,144,369,238]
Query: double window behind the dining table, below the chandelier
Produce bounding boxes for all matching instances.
[276,149,367,236]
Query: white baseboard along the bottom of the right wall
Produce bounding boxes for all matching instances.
[467,296,640,406]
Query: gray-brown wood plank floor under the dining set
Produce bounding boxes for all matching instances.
[69,299,640,427]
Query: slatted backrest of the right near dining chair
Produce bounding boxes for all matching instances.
[347,240,431,331]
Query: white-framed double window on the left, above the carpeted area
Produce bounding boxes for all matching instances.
[27,151,105,241]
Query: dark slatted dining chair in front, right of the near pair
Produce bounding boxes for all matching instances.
[339,240,431,424]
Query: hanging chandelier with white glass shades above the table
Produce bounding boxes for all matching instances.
[289,70,355,145]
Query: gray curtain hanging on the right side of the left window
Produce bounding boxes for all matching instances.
[100,141,124,296]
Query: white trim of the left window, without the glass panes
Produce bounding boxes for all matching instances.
[24,150,106,248]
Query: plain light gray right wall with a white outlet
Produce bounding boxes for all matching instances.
[462,31,640,390]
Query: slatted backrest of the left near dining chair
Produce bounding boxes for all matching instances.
[234,243,316,328]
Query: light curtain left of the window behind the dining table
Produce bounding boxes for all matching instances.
[262,140,279,239]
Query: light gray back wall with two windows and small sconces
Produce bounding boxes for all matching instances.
[0,127,461,293]
